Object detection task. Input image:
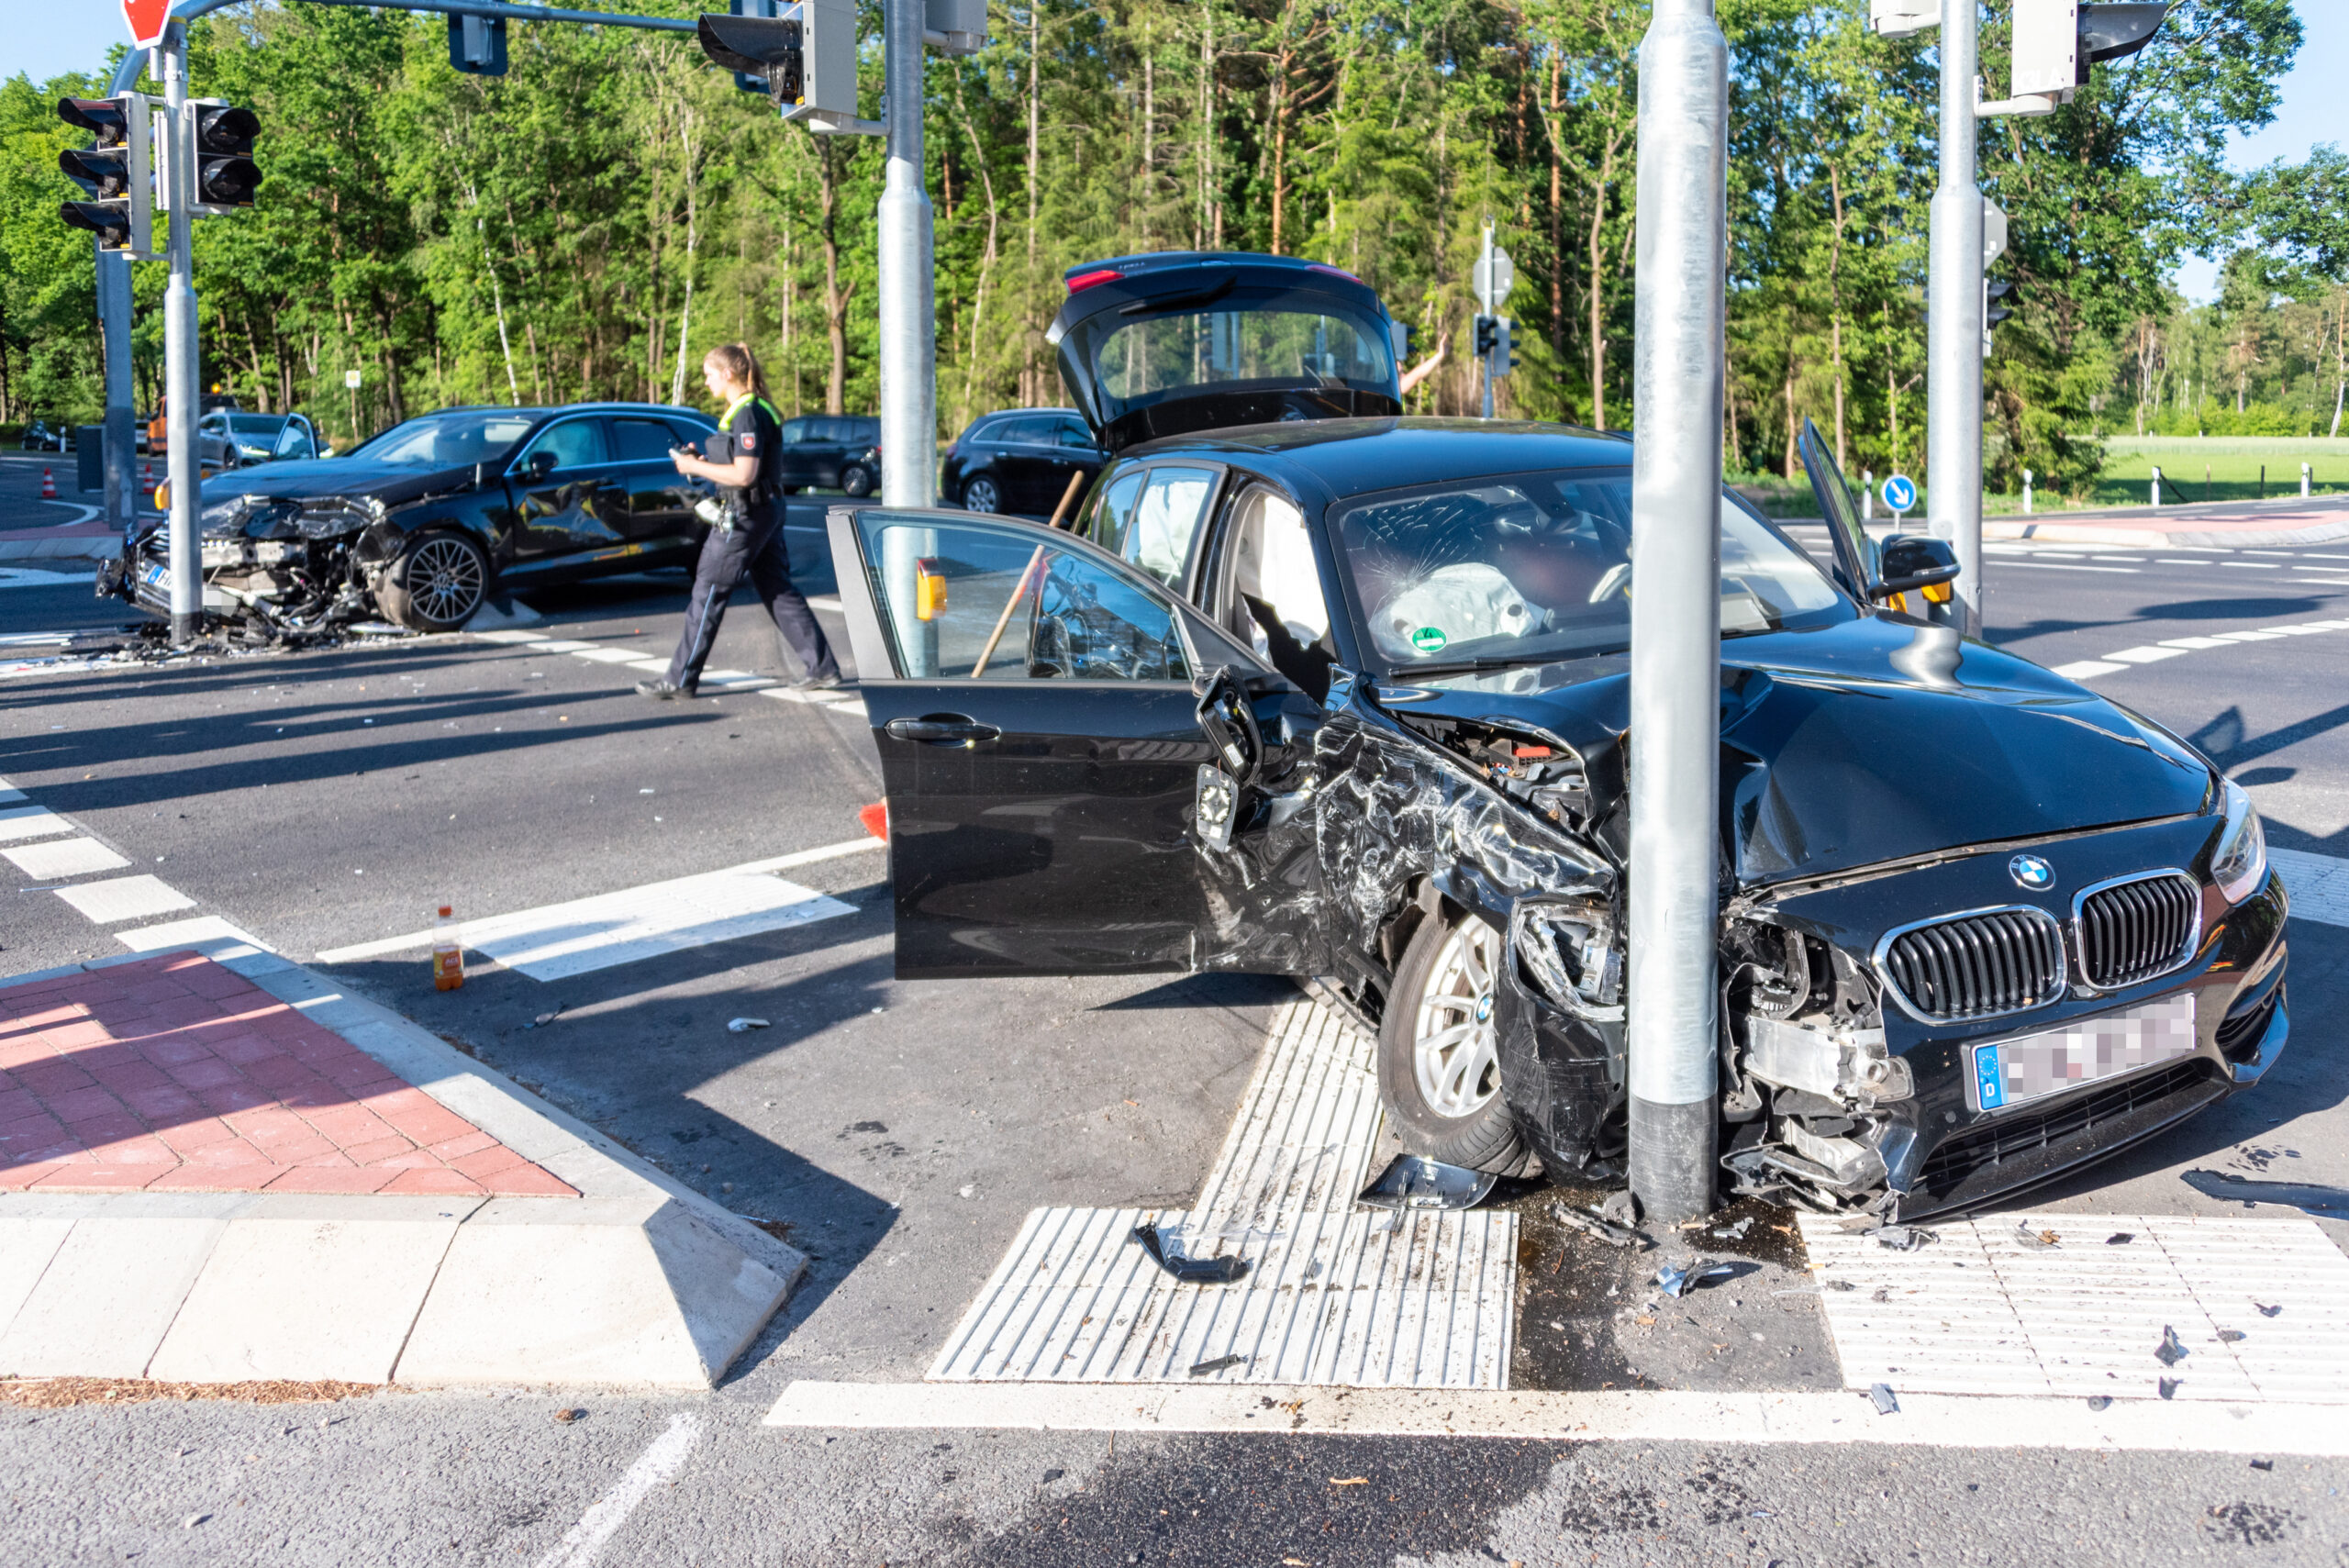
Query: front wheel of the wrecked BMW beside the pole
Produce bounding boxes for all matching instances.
[1379,911,1531,1176]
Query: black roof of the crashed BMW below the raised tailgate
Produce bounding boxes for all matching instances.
[1123,416,1631,497]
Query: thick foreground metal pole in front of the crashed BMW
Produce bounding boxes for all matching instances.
[1628,0,1729,1225]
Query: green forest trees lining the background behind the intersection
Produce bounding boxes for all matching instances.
[0,0,2311,464]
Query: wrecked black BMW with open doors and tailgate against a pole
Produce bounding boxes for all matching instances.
[829,256,2288,1218]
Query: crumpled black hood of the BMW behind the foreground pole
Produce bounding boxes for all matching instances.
[1381,617,2213,885]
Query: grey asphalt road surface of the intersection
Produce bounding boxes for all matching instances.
[0,485,2349,1568]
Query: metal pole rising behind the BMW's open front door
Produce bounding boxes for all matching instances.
[878,0,937,507]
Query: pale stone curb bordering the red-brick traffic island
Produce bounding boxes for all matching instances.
[0,939,808,1390]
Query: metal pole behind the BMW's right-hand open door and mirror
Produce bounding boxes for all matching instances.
[1926,0,1983,634]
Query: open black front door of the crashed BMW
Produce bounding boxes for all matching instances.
[829,507,1327,979]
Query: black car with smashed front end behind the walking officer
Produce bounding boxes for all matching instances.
[99,404,717,631]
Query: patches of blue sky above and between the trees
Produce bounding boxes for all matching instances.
[0,0,2349,300]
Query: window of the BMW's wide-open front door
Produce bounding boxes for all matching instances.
[857,512,1191,681]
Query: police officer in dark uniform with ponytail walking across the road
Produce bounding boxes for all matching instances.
[637,343,841,699]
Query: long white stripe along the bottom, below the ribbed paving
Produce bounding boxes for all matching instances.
[766,1380,2349,1455]
